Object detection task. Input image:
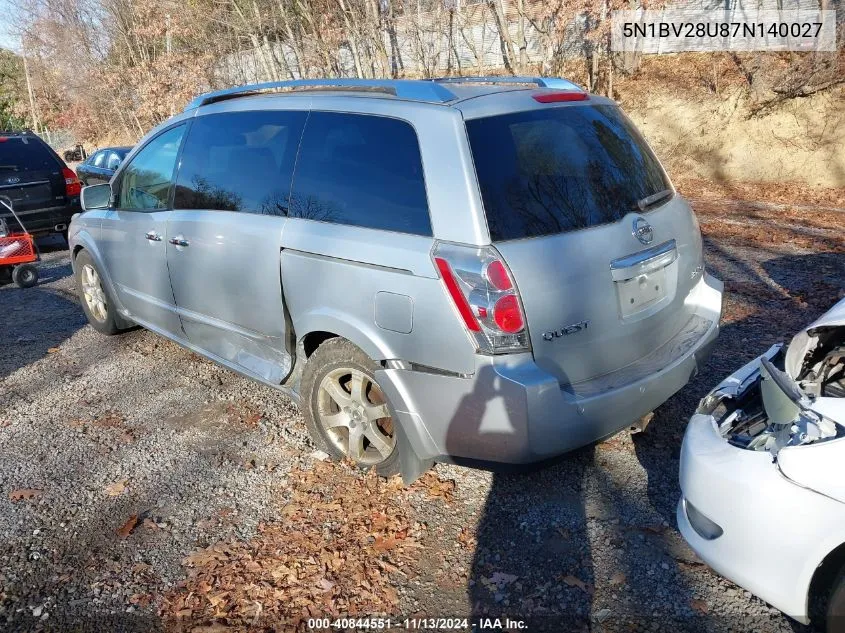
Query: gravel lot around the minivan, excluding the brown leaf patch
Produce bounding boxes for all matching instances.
[0,215,845,632]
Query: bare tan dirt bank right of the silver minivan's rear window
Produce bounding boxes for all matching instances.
[622,87,845,188]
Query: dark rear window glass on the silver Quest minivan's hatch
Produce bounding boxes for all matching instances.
[466,105,670,241]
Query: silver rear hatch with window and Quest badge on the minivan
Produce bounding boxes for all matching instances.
[466,99,703,386]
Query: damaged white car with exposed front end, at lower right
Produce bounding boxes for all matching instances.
[678,300,845,632]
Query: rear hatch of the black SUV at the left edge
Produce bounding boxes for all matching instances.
[0,136,67,222]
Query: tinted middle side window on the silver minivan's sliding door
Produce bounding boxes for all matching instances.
[174,110,306,215]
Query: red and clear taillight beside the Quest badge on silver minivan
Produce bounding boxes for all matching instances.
[432,243,529,354]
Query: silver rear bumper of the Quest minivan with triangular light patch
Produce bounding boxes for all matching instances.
[377,275,723,464]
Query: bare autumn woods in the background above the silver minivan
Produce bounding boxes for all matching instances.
[0,0,845,145]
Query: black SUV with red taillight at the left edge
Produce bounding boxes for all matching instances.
[0,132,82,236]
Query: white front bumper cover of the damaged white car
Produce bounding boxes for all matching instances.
[677,414,845,623]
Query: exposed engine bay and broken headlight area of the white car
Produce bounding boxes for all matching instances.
[697,319,845,456]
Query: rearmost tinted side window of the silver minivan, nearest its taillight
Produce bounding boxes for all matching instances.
[290,112,431,235]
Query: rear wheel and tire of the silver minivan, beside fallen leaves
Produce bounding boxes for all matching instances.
[301,338,401,477]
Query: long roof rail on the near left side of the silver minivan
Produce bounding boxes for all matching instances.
[185,78,456,111]
